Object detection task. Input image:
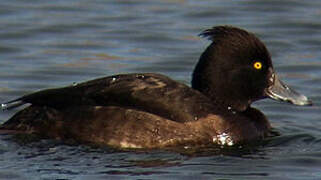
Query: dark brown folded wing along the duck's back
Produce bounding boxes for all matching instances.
[2,73,212,122]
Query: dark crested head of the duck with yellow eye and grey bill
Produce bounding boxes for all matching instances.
[192,26,311,112]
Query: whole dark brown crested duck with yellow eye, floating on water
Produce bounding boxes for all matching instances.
[0,25,312,149]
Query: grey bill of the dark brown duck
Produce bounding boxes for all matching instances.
[265,74,312,106]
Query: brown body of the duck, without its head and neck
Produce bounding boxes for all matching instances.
[2,73,270,148]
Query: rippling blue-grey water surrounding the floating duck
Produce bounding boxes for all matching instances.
[0,0,321,180]
